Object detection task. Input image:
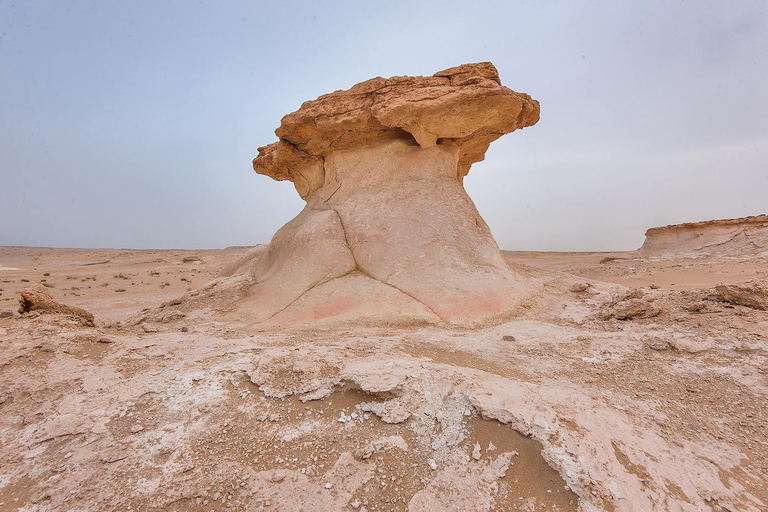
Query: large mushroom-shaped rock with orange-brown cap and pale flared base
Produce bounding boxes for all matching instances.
[224,62,539,327]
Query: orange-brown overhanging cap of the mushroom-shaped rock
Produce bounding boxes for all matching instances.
[253,62,539,199]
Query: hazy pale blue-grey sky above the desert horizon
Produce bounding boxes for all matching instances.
[0,0,768,251]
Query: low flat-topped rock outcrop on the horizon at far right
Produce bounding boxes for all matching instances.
[640,215,768,256]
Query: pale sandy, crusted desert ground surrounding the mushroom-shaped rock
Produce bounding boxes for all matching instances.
[0,247,768,511]
